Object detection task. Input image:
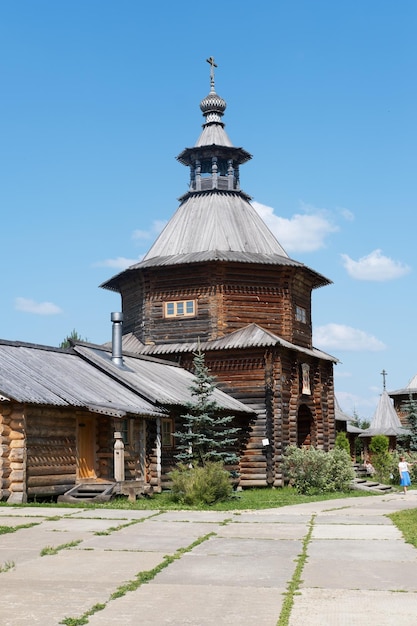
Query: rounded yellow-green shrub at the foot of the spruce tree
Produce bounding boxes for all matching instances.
[170,462,233,505]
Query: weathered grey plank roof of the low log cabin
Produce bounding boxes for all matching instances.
[0,340,252,417]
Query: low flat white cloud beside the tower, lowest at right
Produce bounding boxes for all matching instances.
[314,324,386,352]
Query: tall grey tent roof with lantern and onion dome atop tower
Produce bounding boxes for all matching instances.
[101,64,331,291]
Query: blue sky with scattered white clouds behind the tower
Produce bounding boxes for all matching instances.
[0,0,417,419]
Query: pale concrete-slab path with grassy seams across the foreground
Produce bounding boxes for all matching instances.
[0,491,417,626]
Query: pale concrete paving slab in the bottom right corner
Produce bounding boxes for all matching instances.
[289,589,417,626]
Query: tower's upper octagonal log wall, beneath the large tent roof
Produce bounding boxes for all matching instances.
[120,263,314,347]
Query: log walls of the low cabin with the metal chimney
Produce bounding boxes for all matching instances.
[0,403,151,503]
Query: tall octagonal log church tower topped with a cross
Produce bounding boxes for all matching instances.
[102,59,337,487]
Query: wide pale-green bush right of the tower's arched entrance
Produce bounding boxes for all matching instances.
[284,446,355,495]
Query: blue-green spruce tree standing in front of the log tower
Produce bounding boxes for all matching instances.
[174,350,239,467]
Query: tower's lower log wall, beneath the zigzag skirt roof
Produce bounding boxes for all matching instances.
[178,348,335,487]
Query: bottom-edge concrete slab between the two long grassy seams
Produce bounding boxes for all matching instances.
[87,583,282,626]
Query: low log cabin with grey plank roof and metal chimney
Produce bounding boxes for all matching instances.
[0,334,252,503]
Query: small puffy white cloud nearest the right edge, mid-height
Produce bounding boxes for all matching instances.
[341,250,411,281]
